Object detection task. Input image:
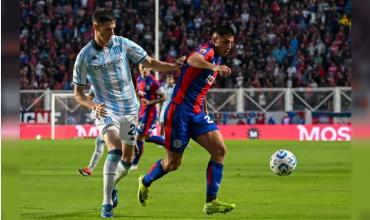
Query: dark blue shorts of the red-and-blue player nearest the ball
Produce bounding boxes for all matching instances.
[164,102,218,153]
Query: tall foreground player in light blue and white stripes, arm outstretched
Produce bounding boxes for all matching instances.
[73,9,185,218]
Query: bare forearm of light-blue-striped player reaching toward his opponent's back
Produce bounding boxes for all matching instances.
[142,56,186,72]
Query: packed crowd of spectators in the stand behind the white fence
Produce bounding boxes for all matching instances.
[20,0,352,90]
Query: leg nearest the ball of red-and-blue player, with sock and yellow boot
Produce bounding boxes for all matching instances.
[196,130,235,215]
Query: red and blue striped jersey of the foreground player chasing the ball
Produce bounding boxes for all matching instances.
[172,42,222,113]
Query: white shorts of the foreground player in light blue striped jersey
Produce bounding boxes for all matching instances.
[95,114,137,145]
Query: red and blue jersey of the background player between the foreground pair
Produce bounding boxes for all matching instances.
[136,75,160,117]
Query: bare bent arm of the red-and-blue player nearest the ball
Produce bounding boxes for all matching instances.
[188,53,231,76]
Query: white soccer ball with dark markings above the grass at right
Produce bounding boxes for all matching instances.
[270,149,297,176]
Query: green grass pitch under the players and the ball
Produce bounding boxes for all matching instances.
[20,140,351,220]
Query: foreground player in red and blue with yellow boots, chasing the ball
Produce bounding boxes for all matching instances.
[138,26,235,215]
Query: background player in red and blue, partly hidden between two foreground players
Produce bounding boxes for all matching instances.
[131,65,166,169]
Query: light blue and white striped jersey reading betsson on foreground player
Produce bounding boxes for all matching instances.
[73,35,148,115]
